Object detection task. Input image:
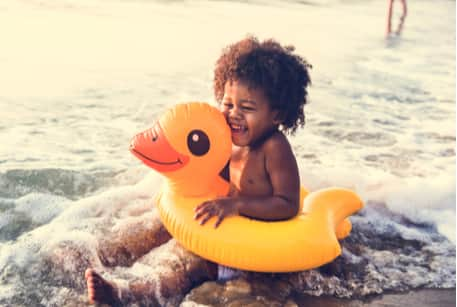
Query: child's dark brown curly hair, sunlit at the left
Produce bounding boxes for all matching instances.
[213,36,312,134]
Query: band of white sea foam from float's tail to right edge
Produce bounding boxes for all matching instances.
[300,167,456,243]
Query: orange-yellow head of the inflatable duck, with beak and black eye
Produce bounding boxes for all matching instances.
[130,102,231,194]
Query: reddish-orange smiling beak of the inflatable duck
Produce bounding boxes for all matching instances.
[130,123,189,173]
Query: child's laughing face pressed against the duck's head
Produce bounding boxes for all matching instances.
[221,81,280,146]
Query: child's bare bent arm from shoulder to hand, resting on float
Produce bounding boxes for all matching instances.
[195,135,300,227]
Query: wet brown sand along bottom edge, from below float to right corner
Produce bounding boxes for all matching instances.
[180,278,456,307]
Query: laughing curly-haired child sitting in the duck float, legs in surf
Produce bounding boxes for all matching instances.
[85,37,311,304]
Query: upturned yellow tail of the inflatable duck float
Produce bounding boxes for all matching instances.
[303,188,363,239]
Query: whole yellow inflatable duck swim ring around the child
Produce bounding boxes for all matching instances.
[130,102,363,272]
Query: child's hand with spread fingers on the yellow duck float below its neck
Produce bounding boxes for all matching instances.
[194,198,239,228]
